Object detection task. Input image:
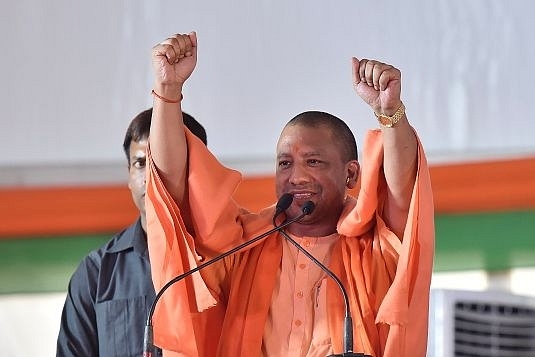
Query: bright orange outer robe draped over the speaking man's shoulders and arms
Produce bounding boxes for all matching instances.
[147,130,434,357]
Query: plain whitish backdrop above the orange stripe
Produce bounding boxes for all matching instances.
[0,0,535,184]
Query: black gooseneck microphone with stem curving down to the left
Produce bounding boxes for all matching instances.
[143,193,306,357]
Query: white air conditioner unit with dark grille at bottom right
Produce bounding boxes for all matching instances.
[427,289,535,357]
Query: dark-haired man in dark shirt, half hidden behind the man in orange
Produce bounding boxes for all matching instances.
[56,108,206,357]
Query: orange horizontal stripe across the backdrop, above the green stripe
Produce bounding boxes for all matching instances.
[0,157,535,238]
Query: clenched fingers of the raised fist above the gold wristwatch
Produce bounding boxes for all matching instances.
[353,57,401,91]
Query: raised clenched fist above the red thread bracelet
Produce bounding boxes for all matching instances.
[152,32,197,94]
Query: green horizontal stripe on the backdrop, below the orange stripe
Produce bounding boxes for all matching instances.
[0,210,535,294]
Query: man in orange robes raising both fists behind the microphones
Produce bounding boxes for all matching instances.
[147,32,434,357]
